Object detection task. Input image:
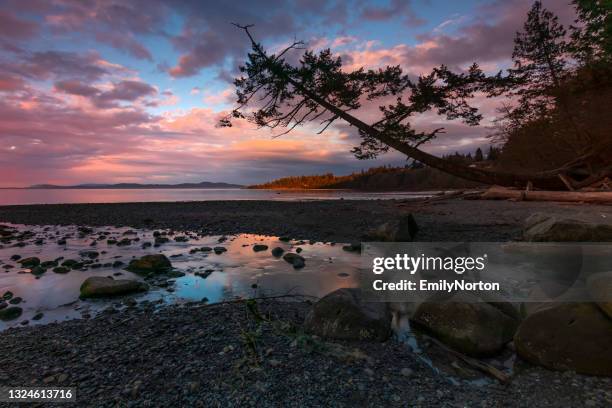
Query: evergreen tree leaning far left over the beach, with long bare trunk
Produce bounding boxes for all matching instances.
[221,11,612,189]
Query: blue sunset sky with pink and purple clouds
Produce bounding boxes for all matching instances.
[0,0,574,187]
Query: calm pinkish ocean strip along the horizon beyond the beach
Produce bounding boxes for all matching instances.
[0,189,436,205]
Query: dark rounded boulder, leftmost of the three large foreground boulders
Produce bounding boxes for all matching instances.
[304,288,392,341]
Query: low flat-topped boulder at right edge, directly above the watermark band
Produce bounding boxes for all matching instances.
[523,213,612,242]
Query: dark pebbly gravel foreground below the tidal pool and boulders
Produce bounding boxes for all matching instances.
[0,300,612,407]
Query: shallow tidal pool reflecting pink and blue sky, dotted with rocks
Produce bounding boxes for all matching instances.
[0,224,360,330]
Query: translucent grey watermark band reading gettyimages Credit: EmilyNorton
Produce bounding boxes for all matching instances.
[359,242,612,302]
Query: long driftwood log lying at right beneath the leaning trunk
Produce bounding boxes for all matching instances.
[481,186,612,204]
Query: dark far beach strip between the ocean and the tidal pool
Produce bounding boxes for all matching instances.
[0,200,612,242]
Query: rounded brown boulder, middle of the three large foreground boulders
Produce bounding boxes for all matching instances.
[411,293,520,357]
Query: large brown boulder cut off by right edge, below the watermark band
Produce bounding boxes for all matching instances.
[514,303,612,376]
